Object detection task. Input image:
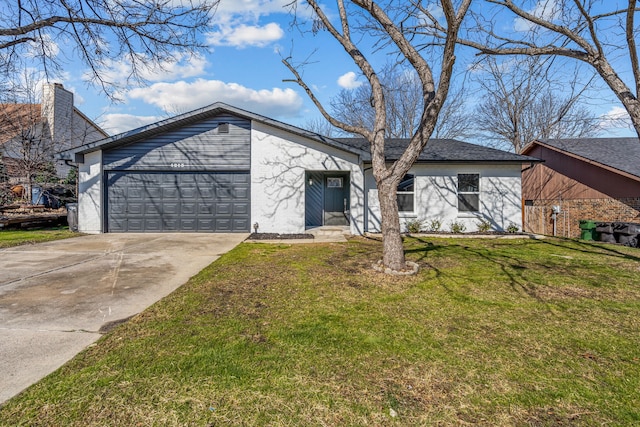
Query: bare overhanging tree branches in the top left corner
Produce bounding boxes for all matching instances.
[0,0,219,96]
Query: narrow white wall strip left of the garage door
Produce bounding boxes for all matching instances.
[78,151,103,234]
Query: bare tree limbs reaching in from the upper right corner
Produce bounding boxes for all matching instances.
[458,0,640,136]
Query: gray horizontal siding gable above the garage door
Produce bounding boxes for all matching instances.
[103,114,251,171]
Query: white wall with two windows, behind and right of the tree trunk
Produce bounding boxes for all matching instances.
[366,164,522,232]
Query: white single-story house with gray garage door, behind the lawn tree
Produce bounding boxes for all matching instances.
[59,103,537,234]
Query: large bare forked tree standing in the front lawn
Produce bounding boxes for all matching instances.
[283,0,471,270]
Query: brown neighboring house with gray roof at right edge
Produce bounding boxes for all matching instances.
[522,138,640,237]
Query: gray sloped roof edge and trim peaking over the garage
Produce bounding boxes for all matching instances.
[57,102,366,159]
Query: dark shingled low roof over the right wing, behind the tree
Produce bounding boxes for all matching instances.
[336,138,541,163]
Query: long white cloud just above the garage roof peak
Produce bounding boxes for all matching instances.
[128,79,303,117]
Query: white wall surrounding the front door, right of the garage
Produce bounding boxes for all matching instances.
[251,122,364,234]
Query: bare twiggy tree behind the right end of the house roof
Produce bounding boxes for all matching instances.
[475,57,600,153]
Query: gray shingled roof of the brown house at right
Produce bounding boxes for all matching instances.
[523,138,640,177]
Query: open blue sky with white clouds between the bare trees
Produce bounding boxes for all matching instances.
[42,0,635,136]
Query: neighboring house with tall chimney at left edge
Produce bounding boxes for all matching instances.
[0,83,108,183]
